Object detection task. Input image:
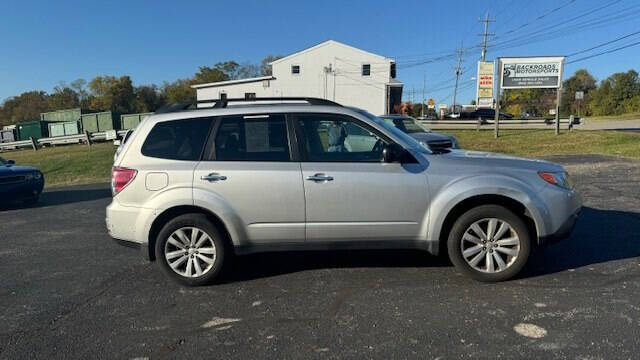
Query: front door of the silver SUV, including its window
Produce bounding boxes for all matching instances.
[295,114,429,241]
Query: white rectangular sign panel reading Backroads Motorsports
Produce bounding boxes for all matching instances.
[500,57,564,89]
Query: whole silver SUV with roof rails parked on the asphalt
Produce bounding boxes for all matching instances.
[106,98,581,285]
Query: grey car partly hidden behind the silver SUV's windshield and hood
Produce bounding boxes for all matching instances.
[379,115,460,151]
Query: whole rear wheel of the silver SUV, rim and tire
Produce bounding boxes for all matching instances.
[155,214,228,286]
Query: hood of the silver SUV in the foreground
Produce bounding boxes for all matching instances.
[439,149,564,172]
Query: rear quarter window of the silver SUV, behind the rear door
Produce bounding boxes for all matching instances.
[142,118,211,161]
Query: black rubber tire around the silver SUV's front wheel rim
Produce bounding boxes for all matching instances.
[447,205,531,282]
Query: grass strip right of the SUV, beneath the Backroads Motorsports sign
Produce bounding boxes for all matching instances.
[443,130,640,159]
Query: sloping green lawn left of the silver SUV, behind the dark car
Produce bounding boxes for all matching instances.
[0,142,116,187]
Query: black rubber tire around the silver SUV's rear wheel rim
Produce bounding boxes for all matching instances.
[155,214,232,286]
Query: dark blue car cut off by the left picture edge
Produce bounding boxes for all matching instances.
[0,157,44,204]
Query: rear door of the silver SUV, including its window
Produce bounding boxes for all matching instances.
[193,114,304,244]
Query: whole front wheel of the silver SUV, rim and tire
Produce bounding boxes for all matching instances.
[447,205,531,282]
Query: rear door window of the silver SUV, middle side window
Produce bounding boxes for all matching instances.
[215,114,291,161]
